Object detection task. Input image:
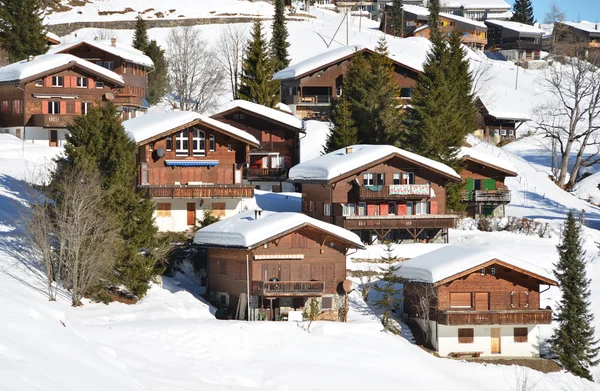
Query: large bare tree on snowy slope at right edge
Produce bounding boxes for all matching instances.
[536,52,600,188]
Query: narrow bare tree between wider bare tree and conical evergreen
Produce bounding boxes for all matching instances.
[215,25,248,99]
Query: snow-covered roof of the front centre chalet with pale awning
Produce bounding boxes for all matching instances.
[194,210,364,248]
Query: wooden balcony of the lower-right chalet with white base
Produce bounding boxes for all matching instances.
[438,309,552,326]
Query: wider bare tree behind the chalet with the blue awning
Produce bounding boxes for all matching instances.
[167,26,225,113]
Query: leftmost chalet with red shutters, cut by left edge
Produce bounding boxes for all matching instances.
[0,54,125,147]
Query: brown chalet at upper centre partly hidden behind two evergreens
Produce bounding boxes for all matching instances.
[274,46,419,119]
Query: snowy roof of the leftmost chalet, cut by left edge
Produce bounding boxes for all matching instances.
[0,54,124,86]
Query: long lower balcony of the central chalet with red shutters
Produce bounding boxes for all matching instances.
[342,215,458,230]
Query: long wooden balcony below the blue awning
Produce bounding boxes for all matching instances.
[138,185,254,198]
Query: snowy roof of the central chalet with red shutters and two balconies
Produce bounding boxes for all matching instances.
[289,144,460,182]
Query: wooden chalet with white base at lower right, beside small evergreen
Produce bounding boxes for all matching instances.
[398,246,557,357]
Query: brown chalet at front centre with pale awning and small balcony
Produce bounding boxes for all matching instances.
[194,210,363,320]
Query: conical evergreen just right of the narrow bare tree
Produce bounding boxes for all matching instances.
[239,19,279,107]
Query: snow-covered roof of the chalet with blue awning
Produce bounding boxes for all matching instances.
[123,111,260,146]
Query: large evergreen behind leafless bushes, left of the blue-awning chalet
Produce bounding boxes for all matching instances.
[55,102,162,297]
